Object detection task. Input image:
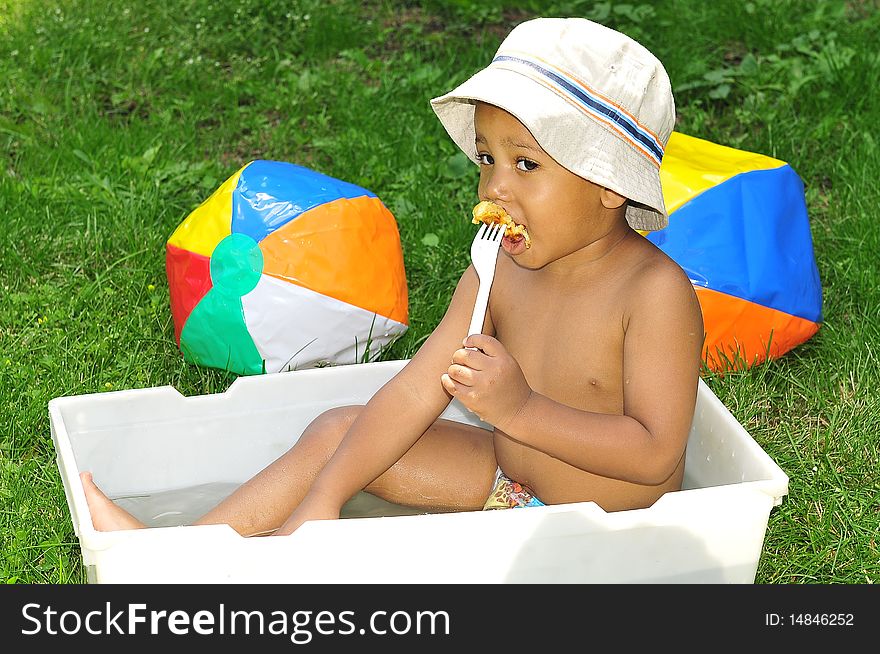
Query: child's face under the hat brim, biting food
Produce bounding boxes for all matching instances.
[474,103,626,269]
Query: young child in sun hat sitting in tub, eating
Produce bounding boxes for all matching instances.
[82,18,703,535]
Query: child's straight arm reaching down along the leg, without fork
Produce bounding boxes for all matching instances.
[277,267,479,534]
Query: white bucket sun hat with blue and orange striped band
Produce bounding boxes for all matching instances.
[431,18,675,231]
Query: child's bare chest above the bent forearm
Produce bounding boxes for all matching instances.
[489,270,625,413]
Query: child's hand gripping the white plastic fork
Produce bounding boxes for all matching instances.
[440,334,532,431]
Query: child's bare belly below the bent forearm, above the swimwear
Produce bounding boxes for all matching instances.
[495,430,684,511]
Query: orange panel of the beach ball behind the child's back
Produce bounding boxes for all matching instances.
[694,286,819,372]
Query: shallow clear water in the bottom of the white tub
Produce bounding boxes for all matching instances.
[113,482,434,527]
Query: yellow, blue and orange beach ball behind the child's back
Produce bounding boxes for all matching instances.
[646,132,822,371]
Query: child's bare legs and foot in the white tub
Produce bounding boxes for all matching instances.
[83,406,497,536]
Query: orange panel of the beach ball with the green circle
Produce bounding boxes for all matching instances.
[260,197,409,325]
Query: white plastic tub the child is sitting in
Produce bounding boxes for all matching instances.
[49,361,788,583]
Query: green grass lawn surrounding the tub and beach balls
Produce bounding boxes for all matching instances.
[0,0,880,584]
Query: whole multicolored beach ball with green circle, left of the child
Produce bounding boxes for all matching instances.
[166,160,408,375]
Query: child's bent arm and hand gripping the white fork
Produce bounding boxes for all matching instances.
[443,264,703,484]
